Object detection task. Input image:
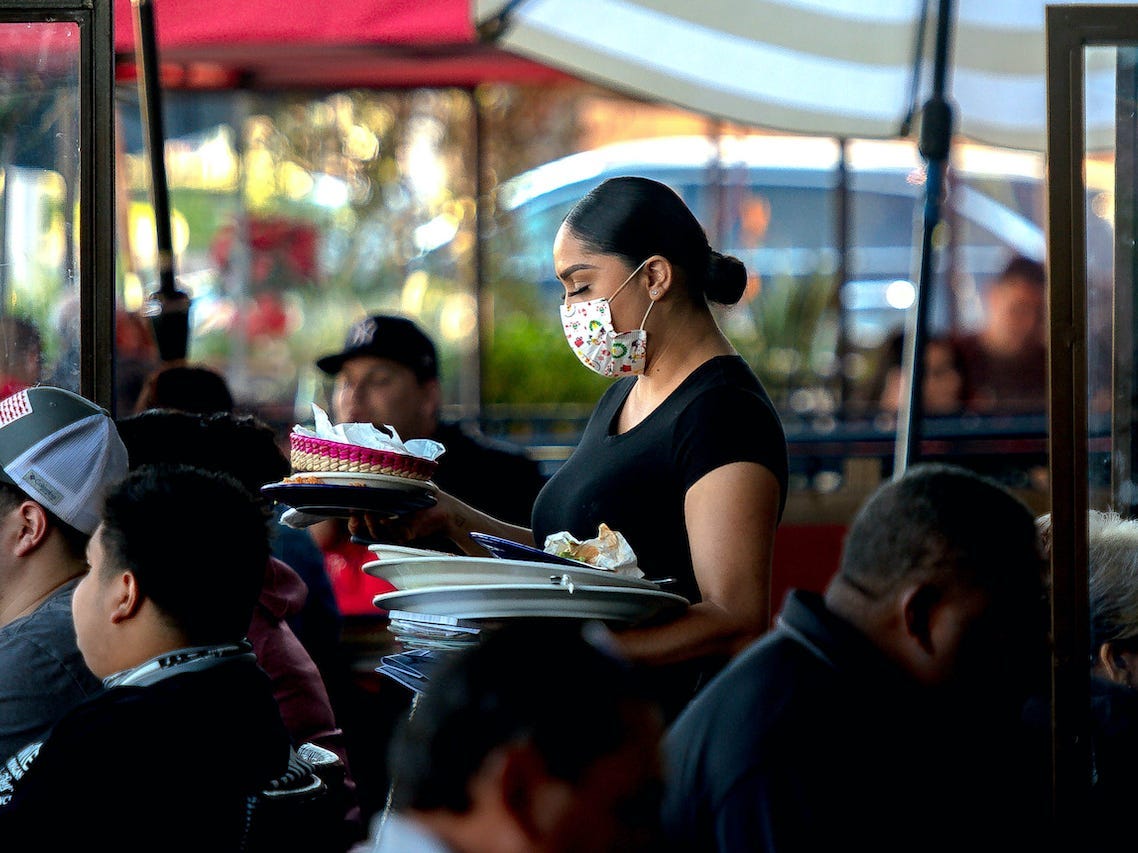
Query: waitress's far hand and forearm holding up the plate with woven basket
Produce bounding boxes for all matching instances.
[348,490,534,556]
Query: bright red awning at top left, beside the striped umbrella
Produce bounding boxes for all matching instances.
[115,0,564,89]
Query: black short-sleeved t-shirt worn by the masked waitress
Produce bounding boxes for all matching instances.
[533,356,787,602]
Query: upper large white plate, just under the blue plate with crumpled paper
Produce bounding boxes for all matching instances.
[362,554,660,590]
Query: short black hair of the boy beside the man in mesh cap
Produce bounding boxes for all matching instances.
[101,465,269,645]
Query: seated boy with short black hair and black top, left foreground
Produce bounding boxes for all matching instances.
[0,466,330,851]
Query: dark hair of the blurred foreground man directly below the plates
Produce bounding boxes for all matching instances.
[390,624,660,850]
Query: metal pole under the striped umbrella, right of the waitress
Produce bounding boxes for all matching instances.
[893,0,953,479]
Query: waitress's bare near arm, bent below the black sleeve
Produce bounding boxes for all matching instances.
[616,462,780,664]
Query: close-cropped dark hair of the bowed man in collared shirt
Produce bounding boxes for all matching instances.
[839,463,1042,594]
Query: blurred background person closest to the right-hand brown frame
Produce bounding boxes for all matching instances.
[958,256,1047,414]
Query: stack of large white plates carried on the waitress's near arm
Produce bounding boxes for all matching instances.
[363,545,688,626]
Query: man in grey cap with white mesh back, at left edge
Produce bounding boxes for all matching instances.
[0,386,126,764]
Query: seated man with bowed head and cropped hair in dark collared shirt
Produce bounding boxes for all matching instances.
[663,464,1050,851]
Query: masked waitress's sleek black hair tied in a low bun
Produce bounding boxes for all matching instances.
[564,176,747,305]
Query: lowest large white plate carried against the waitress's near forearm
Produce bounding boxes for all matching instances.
[374,583,688,623]
